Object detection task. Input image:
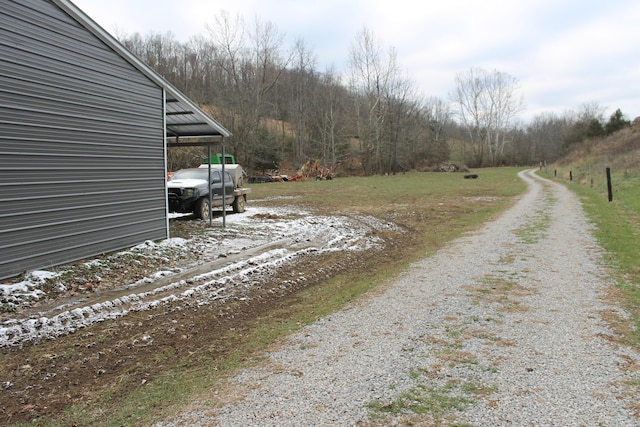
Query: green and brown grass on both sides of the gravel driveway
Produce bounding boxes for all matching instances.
[16,166,640,426]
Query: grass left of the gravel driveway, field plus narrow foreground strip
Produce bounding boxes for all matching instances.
[139,168,526,425]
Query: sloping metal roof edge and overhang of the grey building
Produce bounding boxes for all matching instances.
[52,0,231,142]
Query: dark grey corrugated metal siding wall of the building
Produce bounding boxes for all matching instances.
[0,0,167,278]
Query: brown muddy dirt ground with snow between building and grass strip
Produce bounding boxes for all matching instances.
[0,209,403,425]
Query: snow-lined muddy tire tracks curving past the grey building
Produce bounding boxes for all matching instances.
[0,211,395,348]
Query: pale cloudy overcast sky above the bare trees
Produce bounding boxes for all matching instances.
[72,0,640,121]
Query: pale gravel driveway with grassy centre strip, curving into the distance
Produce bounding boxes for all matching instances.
[157,171,640,427]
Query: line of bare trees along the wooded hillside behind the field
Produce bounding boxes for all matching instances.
[118,12,629,175]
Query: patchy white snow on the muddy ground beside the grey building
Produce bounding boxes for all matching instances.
[0,207,398,347]
